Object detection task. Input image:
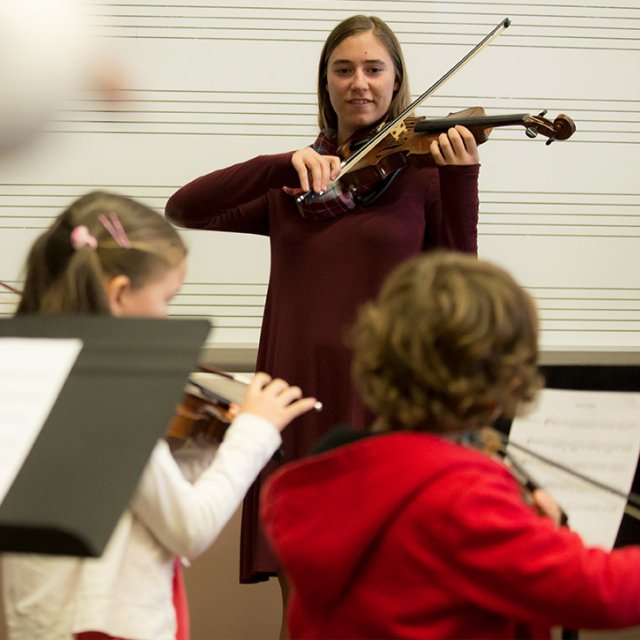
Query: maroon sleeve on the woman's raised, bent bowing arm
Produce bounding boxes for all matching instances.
[165,152,298,235]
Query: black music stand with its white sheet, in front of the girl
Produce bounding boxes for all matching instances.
[0,316,211,556]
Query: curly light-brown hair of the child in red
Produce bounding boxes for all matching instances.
[352,251,542,432]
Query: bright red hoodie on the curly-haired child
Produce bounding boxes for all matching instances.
[262,432,640,640]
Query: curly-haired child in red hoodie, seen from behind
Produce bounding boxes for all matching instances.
[262,252,640,640]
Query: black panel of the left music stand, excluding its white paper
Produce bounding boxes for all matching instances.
[0,316,211,556]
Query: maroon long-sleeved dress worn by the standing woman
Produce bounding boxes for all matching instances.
[166,144,479,582]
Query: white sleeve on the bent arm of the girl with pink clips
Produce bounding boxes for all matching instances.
[131,414,281,558]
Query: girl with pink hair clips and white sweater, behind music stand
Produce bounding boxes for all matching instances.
[3,192,314,640]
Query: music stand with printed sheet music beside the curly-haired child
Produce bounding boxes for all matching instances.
[500,365,640,549]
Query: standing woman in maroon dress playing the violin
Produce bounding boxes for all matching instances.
[166,15,479,582]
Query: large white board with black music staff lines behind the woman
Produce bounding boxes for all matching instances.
[0,0,640,360]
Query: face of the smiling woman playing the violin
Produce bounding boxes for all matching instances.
[327,31,397,144]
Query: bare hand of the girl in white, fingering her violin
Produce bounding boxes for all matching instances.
[240,373,316,431]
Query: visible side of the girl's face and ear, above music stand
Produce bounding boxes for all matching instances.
[106,258,187,318]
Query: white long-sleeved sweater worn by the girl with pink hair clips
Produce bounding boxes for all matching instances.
[3,413,281,640]
